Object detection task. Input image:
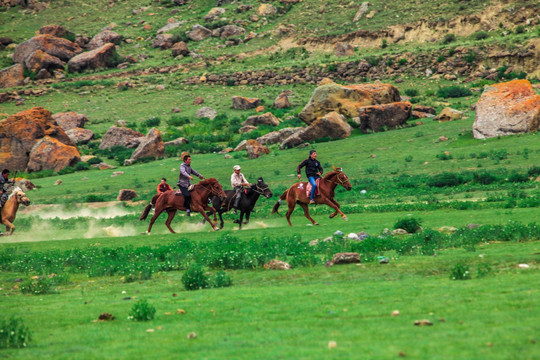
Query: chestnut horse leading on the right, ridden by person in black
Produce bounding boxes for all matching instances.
[272,168,352,226]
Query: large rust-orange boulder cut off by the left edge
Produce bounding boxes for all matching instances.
[0,107,74,171]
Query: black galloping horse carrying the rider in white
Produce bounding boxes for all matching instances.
[207,177,272,229]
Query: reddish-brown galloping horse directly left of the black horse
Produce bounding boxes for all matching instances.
[143,178,226,234]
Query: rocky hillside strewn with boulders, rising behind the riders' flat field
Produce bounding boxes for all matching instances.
[0,0,540,171]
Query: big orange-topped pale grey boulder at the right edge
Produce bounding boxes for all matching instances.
[473,80,540,139]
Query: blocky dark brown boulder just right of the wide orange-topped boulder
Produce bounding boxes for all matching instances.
[358,102,412,132]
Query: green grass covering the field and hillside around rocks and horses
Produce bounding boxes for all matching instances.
[0,0,540,360]
